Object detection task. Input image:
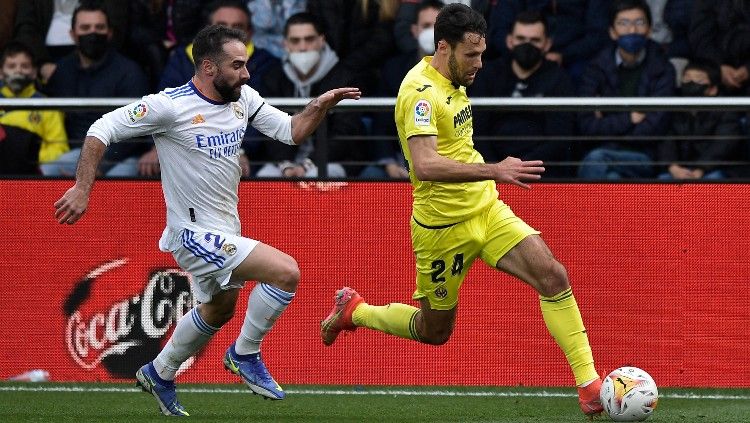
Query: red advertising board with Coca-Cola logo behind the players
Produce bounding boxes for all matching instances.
[0,181,750,387]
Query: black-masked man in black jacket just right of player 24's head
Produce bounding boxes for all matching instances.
[469,11,575,177]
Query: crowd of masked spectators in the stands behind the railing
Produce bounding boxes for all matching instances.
[0,0,750,180]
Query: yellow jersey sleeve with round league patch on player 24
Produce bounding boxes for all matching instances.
[399,87,439,139]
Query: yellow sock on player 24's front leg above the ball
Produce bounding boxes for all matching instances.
[539,288,599,386]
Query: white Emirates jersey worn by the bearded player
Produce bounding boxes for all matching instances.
[88,81,294,251]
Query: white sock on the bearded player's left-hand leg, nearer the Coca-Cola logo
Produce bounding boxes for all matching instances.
[154,307,219,380]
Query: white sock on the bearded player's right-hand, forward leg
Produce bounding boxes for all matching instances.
[234,282,294,355]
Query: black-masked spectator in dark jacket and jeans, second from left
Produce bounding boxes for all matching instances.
[42,2,150,176]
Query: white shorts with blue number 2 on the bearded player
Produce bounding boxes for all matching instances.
[171,229,260,303]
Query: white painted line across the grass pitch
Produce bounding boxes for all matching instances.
[0,386,750,400]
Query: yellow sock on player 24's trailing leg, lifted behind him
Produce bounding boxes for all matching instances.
[352,303,419,341]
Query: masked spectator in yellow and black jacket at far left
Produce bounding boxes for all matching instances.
[0,42,69,175]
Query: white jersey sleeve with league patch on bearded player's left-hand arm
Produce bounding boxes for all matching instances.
[86,94,176,145]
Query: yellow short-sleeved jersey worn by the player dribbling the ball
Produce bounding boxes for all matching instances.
[395,56,498,226]
